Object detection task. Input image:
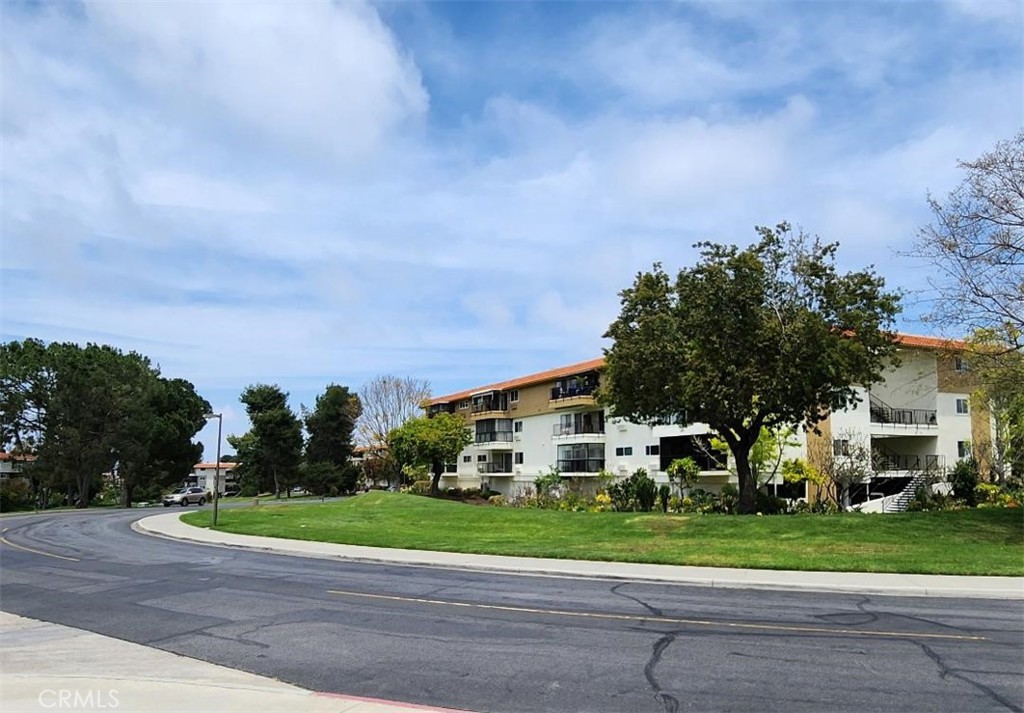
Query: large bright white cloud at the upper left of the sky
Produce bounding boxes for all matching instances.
[87,0,428,158]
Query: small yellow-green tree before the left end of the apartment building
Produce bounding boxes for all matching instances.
[387,413,473,495]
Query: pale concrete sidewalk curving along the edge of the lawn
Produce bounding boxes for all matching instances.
[138,513,1024,599]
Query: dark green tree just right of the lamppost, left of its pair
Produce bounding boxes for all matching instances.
[234,384,302,498]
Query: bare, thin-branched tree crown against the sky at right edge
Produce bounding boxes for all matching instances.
[910,131,1024,351]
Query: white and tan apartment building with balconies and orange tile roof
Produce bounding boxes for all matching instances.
[429,335,992,509]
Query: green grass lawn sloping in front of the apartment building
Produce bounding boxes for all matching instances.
[183,492,1024,576]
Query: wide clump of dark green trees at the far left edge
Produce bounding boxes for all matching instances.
[0,339,209,507]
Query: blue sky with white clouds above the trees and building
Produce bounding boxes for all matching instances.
[0,0,1024,458]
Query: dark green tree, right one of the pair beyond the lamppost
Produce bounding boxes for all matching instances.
[302,384,362,495]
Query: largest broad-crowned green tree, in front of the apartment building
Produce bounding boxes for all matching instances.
[599,223,899,513]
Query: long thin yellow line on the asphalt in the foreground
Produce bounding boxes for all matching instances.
[328,589,987,641]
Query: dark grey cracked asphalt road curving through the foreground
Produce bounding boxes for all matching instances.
[0,511,1024,713]
